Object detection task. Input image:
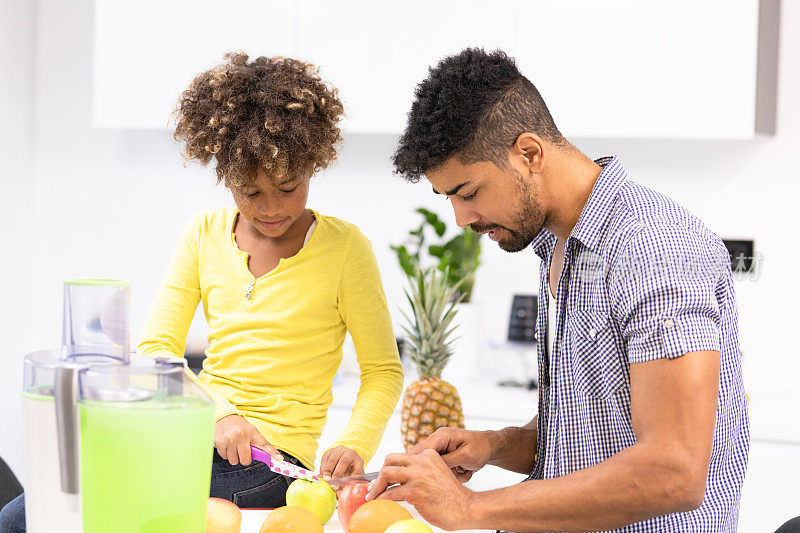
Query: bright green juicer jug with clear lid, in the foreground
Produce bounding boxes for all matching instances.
[64,357,214,533]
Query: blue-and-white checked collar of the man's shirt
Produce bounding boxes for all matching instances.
[531,156,627,259]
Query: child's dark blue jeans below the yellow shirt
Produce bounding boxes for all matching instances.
[0,449,307,533]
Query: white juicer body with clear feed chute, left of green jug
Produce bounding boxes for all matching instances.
[22,278,130,533]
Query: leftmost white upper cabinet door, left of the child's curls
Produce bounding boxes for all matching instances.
[92,0,296,129]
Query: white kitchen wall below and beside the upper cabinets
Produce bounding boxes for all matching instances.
[0,0,800,484]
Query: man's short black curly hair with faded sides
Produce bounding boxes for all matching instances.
[392,48,567,182]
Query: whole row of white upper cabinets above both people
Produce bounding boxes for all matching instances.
[94,0,777,139]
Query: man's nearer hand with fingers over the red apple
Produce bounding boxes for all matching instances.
[367,449,474,530]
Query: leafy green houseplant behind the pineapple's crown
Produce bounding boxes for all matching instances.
[391,207,481,303]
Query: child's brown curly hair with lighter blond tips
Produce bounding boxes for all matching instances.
[174,52,344,186]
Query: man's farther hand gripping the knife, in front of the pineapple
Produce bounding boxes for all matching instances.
[411,428,492,483]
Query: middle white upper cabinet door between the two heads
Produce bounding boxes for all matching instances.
[296,0,516,134]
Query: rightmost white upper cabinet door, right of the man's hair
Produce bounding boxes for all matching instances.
[515,0,774,139]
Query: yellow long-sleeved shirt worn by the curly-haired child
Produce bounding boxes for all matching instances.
[138,208,403,465]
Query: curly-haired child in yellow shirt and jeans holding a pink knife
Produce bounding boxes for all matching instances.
[138,53,403,507]
